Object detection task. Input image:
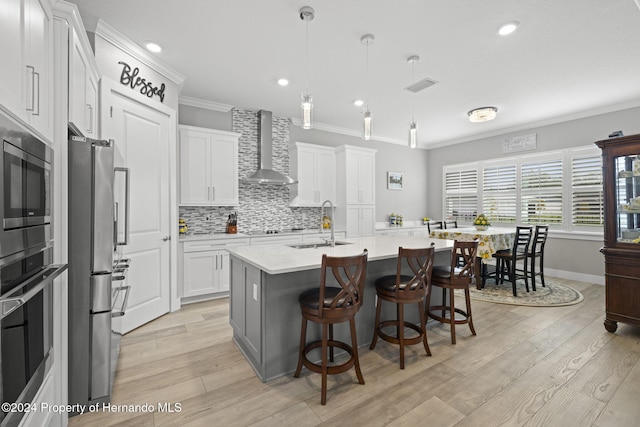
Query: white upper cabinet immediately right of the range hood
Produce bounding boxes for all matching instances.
[289,142,336,206]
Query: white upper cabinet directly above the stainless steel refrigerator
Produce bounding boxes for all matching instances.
[69,28,100,138]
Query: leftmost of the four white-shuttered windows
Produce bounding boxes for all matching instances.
[445,169,478,220]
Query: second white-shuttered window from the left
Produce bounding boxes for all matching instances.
[482,164,517,224]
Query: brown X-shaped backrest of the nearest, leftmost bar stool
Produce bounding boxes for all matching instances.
[318,249,369,319]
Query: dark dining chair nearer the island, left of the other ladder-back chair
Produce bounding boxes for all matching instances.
[493,226,536,297]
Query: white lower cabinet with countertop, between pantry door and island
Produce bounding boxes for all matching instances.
[182,239,249,302]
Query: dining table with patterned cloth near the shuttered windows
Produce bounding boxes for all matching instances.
[429,226,516,289]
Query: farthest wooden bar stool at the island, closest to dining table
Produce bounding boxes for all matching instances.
[427,240,478,344]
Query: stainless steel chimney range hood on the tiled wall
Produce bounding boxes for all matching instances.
[243,110,298,185]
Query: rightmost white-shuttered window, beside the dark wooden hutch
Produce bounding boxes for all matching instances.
[571,155,604,227]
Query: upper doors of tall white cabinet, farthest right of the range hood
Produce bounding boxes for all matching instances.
[336,145,376,205]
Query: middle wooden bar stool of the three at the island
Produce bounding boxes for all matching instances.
[369,243,435,369]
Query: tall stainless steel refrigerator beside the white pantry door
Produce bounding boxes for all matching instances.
[68,136,117,405]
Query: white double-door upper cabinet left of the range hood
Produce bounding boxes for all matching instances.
[180,125,240,206]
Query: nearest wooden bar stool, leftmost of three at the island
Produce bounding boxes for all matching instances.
[293,249,368,405]
